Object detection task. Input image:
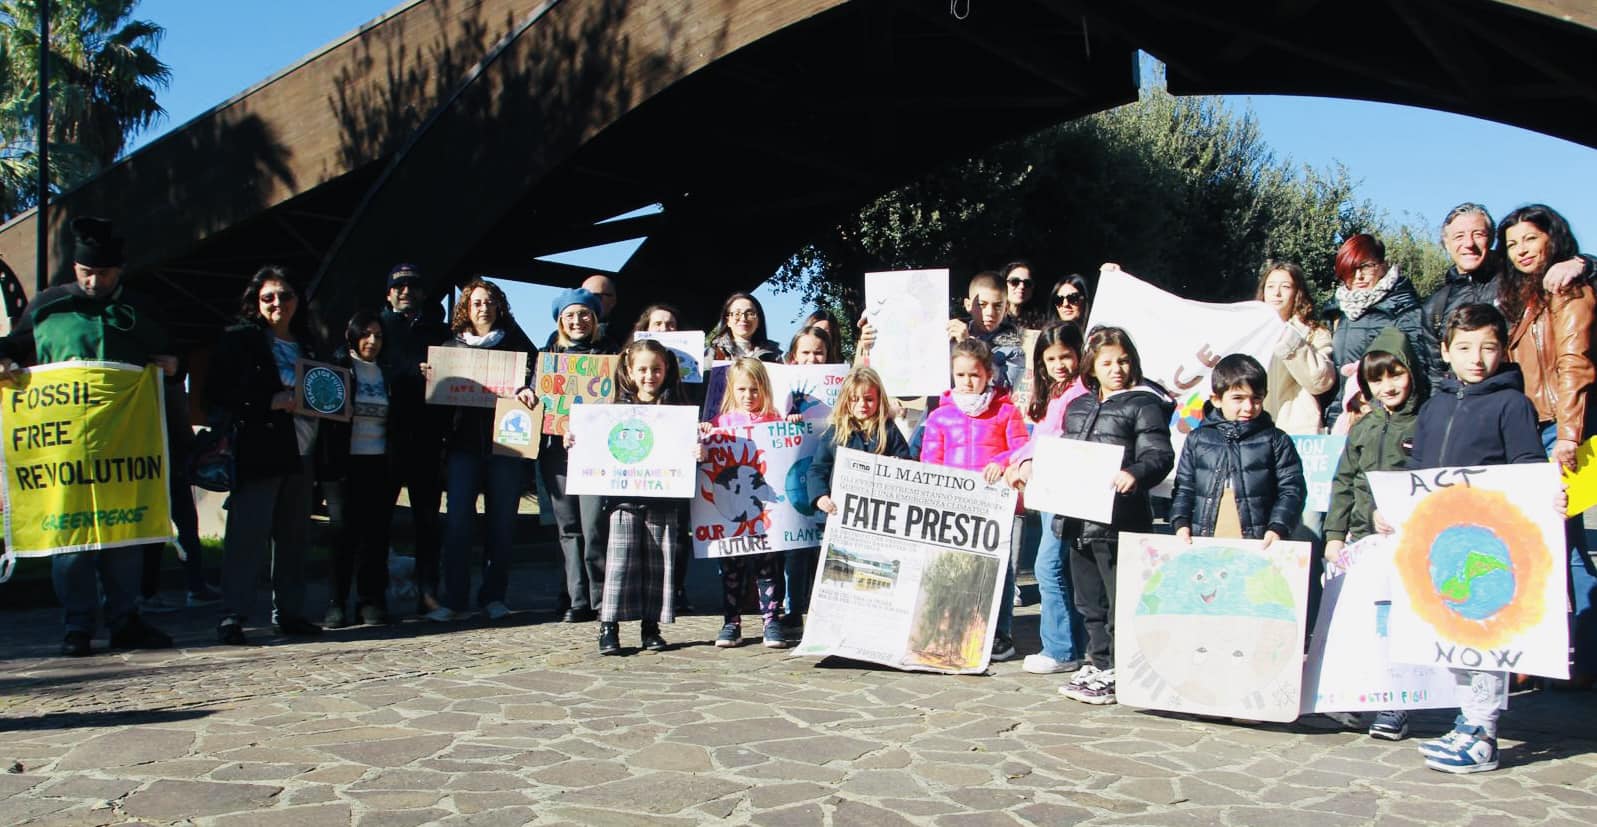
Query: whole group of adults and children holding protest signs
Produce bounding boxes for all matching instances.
[0,203,1597,771]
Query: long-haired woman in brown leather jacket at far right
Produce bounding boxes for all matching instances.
[1498,204,1597,687]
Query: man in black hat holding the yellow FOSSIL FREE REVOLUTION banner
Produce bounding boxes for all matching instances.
[0,217,177,656]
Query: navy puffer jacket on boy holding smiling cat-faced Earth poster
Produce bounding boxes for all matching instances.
[1171,402,1308,540]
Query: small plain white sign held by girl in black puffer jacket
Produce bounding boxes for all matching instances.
[1025,436,1126,522]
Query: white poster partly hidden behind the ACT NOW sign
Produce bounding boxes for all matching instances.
[1302,535,1508,714]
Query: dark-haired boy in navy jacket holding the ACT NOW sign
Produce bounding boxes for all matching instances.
[1405,303,1562,773]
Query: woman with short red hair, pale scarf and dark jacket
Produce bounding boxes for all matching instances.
[1326,233,1437,426]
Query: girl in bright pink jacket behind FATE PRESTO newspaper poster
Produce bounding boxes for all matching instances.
[920,338,1027,661]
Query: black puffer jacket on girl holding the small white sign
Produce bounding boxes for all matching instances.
[1056,382,1175,540]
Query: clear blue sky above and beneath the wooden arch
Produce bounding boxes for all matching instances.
[136,0,1597,340]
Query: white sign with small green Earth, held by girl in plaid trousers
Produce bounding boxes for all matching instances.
[565,406,698,500]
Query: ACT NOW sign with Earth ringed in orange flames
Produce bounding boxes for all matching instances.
[1365,463,1570,679]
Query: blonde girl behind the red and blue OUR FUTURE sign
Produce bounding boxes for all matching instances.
[699,356,797,648]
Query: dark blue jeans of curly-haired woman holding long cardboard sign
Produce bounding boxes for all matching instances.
[442,450,527,611]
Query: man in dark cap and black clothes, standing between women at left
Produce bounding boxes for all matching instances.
[378,263,449,615]
